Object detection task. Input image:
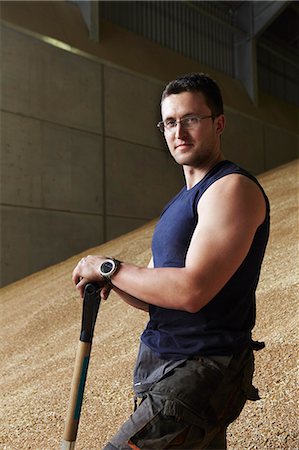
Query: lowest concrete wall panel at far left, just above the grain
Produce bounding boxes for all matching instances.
[1,206,103,284]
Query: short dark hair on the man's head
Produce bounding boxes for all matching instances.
[161,73,223,116]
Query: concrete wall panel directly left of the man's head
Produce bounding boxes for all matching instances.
[104,67,162,148]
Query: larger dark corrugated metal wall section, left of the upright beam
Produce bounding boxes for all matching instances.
[100,1,234,76]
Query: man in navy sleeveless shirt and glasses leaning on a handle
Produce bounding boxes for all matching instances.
[73,74,269,450]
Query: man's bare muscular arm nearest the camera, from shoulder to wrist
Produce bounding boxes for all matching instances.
[74,175,265,313]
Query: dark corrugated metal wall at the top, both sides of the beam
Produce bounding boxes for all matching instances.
[100,1,299,105]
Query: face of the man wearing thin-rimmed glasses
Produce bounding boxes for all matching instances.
[161,92,224,168]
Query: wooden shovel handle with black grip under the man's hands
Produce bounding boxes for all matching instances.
[61,283,101,450]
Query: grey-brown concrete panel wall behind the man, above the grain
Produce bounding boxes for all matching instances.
[1,8,298,285]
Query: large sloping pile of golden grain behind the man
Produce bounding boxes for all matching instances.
[0,162,299,450]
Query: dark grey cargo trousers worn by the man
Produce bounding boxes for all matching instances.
[104,348,257,450]
